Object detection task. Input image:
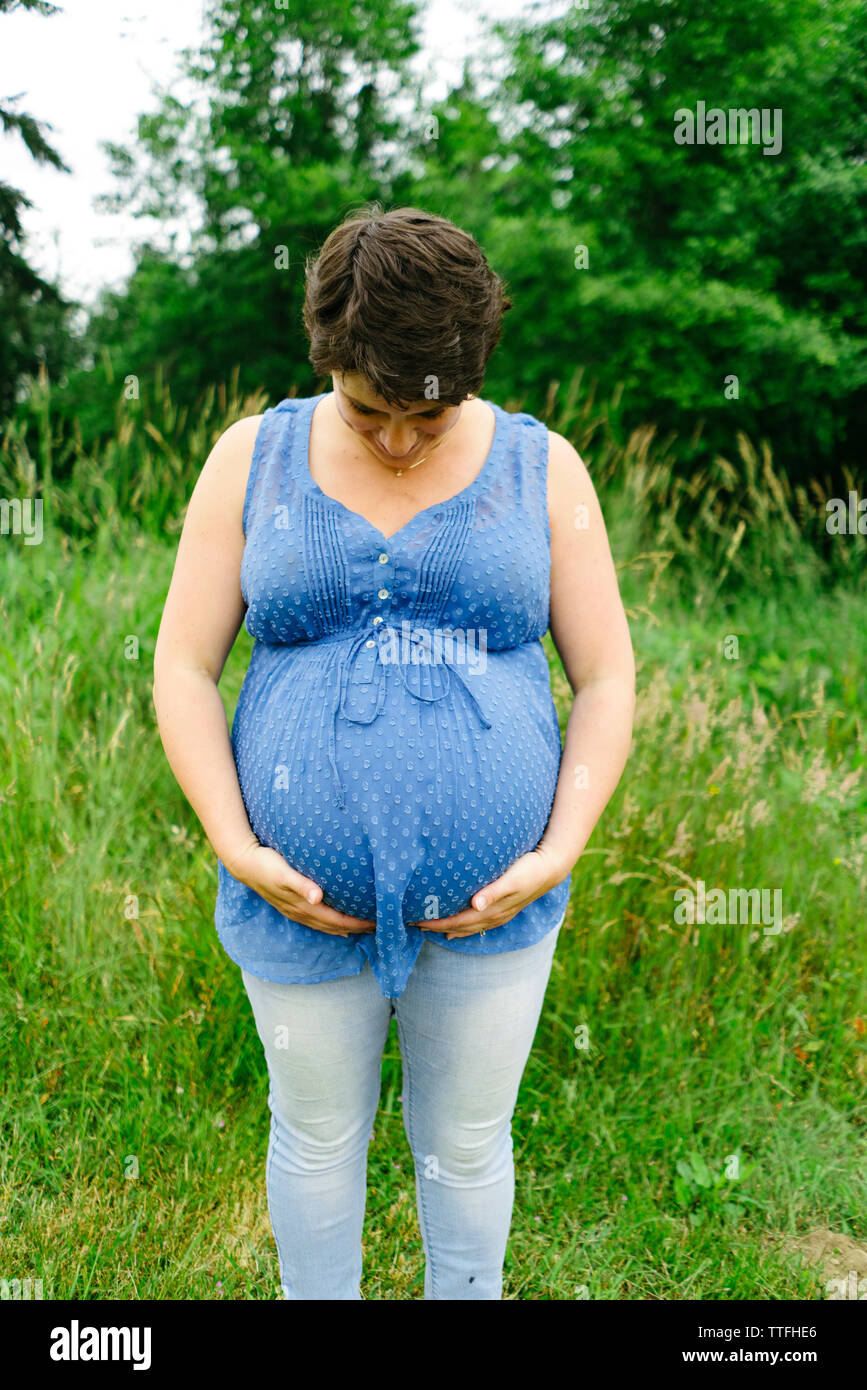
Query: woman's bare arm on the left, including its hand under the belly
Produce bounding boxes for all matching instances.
[153,416,368,934]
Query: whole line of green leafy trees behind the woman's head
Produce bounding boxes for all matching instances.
[10,0,867,489]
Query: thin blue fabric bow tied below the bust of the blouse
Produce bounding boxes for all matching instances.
[328,624,490,808]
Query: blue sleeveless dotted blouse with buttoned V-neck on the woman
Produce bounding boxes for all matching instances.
[214,395,571,998]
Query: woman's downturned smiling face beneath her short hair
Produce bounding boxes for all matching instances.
[331,373,463,468]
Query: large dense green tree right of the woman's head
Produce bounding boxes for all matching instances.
[477,0,867,478]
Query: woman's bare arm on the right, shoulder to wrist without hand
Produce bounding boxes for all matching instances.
[539,431,635,873]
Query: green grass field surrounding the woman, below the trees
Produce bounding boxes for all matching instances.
[0,378,867,1300]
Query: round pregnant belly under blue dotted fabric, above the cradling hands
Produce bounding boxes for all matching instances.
[233,642,560,922]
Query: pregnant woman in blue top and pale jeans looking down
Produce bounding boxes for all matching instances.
[154,206,635,1300]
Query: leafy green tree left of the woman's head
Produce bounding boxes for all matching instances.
[67,0,417,428]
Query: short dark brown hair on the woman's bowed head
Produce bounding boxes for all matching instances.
[304,203,511,407]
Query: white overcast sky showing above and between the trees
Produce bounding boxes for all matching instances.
[0,0,541,312]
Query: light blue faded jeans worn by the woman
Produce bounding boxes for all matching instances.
[242,919,563,1300]
